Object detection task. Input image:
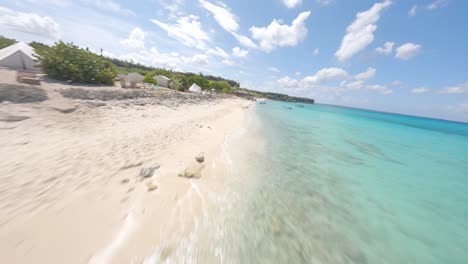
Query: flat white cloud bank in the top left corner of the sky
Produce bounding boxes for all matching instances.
[0,6,60,39]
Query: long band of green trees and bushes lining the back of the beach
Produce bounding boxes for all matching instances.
[0,36,314,103]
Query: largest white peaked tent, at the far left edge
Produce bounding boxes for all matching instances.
[0,42,39,71]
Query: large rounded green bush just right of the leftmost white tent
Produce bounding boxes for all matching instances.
[38,41,116,85]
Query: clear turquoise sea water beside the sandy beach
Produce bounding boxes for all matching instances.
[217,101,468,264]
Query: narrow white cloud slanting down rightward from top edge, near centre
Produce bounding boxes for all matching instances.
[199,0,257,49]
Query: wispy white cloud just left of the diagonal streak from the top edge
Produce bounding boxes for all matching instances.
[151,15,211,50]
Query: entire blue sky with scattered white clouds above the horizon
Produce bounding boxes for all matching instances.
[0,0,468,122]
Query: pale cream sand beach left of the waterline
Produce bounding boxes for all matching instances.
[0,70,251,263]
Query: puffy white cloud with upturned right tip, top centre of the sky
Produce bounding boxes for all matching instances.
[250,11,310,52]
